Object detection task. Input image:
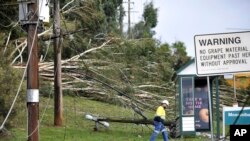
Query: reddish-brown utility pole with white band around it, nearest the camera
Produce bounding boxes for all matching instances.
[26,0,39,141]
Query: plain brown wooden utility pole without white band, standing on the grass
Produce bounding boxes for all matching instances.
[53,0,63,126]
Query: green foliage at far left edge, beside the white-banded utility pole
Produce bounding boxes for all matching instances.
[0,5,24,128]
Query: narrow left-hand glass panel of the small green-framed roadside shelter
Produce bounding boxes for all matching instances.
[181,77,194,115]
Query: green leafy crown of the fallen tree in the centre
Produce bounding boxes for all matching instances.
[80,39,174,104]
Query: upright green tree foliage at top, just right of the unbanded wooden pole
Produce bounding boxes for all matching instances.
[58,0,124,58]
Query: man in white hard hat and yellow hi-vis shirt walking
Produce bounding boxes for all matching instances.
[150,100,169,141]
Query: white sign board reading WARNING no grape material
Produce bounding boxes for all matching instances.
[194,32,250,75]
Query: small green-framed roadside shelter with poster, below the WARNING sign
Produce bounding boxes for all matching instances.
[176,59,212,136]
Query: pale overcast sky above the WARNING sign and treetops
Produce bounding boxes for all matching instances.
[124,0,250,57]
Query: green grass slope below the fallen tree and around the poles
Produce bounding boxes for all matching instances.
[0,96,209,141]
